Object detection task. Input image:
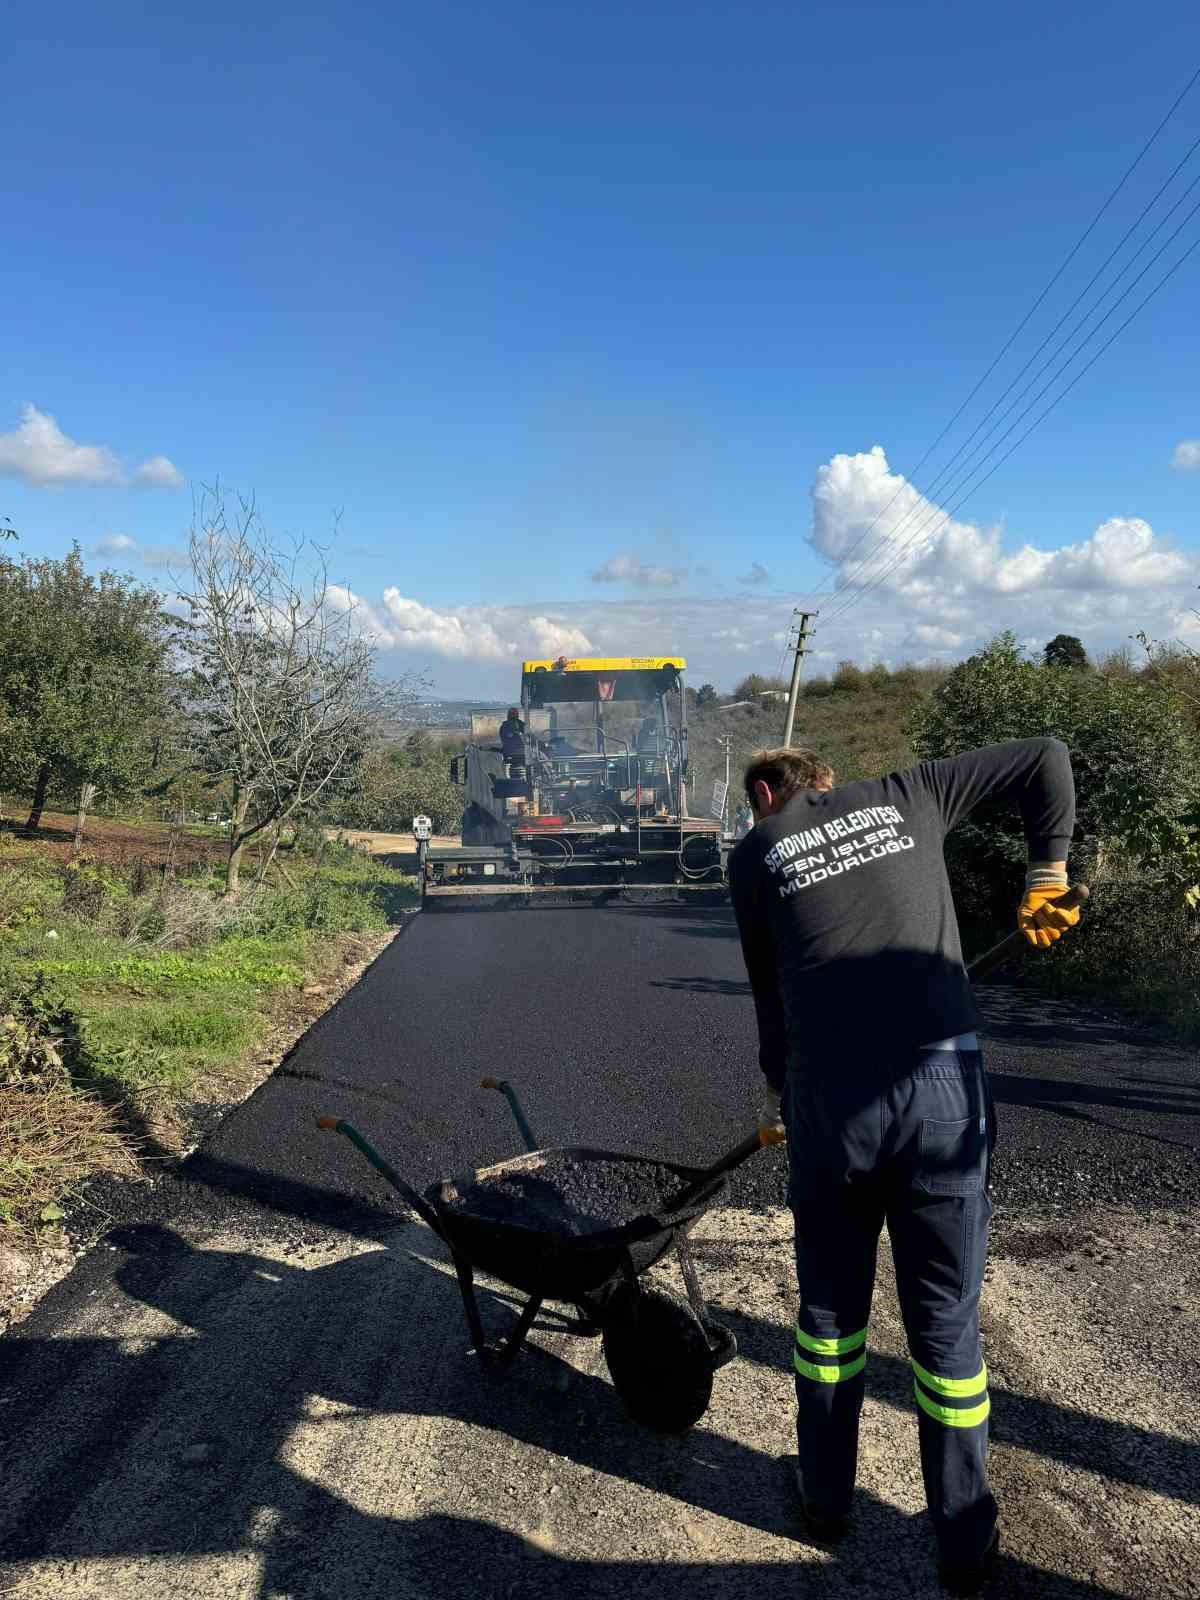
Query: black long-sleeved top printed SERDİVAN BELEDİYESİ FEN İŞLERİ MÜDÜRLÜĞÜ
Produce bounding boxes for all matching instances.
[730,739,1075,1090]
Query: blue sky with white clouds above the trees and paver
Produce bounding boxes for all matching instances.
[0,0,1200,693]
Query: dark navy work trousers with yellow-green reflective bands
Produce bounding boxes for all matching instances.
[784,1050,997,1565]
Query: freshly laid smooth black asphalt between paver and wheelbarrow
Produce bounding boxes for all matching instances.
[91,904,1200,1221]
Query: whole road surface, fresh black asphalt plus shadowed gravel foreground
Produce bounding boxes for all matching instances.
[0,909,1200,1600]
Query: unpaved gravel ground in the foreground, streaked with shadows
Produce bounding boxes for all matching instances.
[0,1211,1200,1600]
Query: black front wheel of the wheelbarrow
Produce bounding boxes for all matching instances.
[603,1288,712,1434]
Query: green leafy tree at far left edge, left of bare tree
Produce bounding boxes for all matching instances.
[0,546,174,842]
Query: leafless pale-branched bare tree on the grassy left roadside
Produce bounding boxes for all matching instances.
[179,490,418,896]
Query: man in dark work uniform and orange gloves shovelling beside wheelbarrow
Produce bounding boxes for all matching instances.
[730,739,1078,1594]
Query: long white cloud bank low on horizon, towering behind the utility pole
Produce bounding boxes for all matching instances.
[316,448,1200,698]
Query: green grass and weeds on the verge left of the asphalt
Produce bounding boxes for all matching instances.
[0,835,416,1237]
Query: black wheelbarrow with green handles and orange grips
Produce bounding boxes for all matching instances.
[317,1078,776,1434]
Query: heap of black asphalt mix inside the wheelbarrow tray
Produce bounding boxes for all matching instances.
[443,1150,683,1238]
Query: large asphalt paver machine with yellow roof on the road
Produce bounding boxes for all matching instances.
[422,656,723,907]
